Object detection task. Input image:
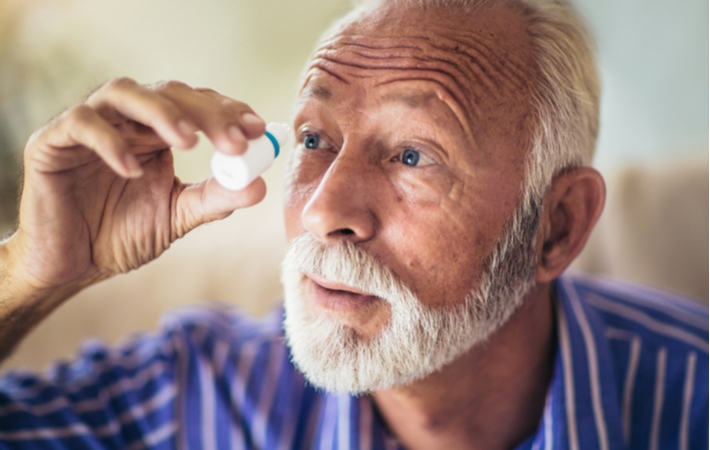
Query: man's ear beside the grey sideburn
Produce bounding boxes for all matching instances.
[535,167,606,282]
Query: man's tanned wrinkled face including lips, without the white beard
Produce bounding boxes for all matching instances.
[285,2,532,390]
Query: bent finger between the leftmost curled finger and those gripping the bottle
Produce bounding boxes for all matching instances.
[86,78,197,149]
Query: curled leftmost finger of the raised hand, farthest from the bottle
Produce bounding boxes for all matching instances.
[28,105,142,178]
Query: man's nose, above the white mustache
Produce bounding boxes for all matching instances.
[301,158,376,243]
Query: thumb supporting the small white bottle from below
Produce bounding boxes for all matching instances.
[170,177,266,242]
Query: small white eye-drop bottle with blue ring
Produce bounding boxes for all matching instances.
[210,123,289,191]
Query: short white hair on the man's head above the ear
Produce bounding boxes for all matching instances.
[342,0,600,204]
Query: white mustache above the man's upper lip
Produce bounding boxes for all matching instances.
[282,233,415,303]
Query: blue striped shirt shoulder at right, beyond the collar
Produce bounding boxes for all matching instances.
[557,273,708,448]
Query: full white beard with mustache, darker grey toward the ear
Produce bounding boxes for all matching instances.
[281,199,539,394]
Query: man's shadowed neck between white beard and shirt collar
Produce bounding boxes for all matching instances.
[373,284,554,450]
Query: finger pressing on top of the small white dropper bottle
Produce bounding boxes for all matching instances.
[160,85,266,154]
